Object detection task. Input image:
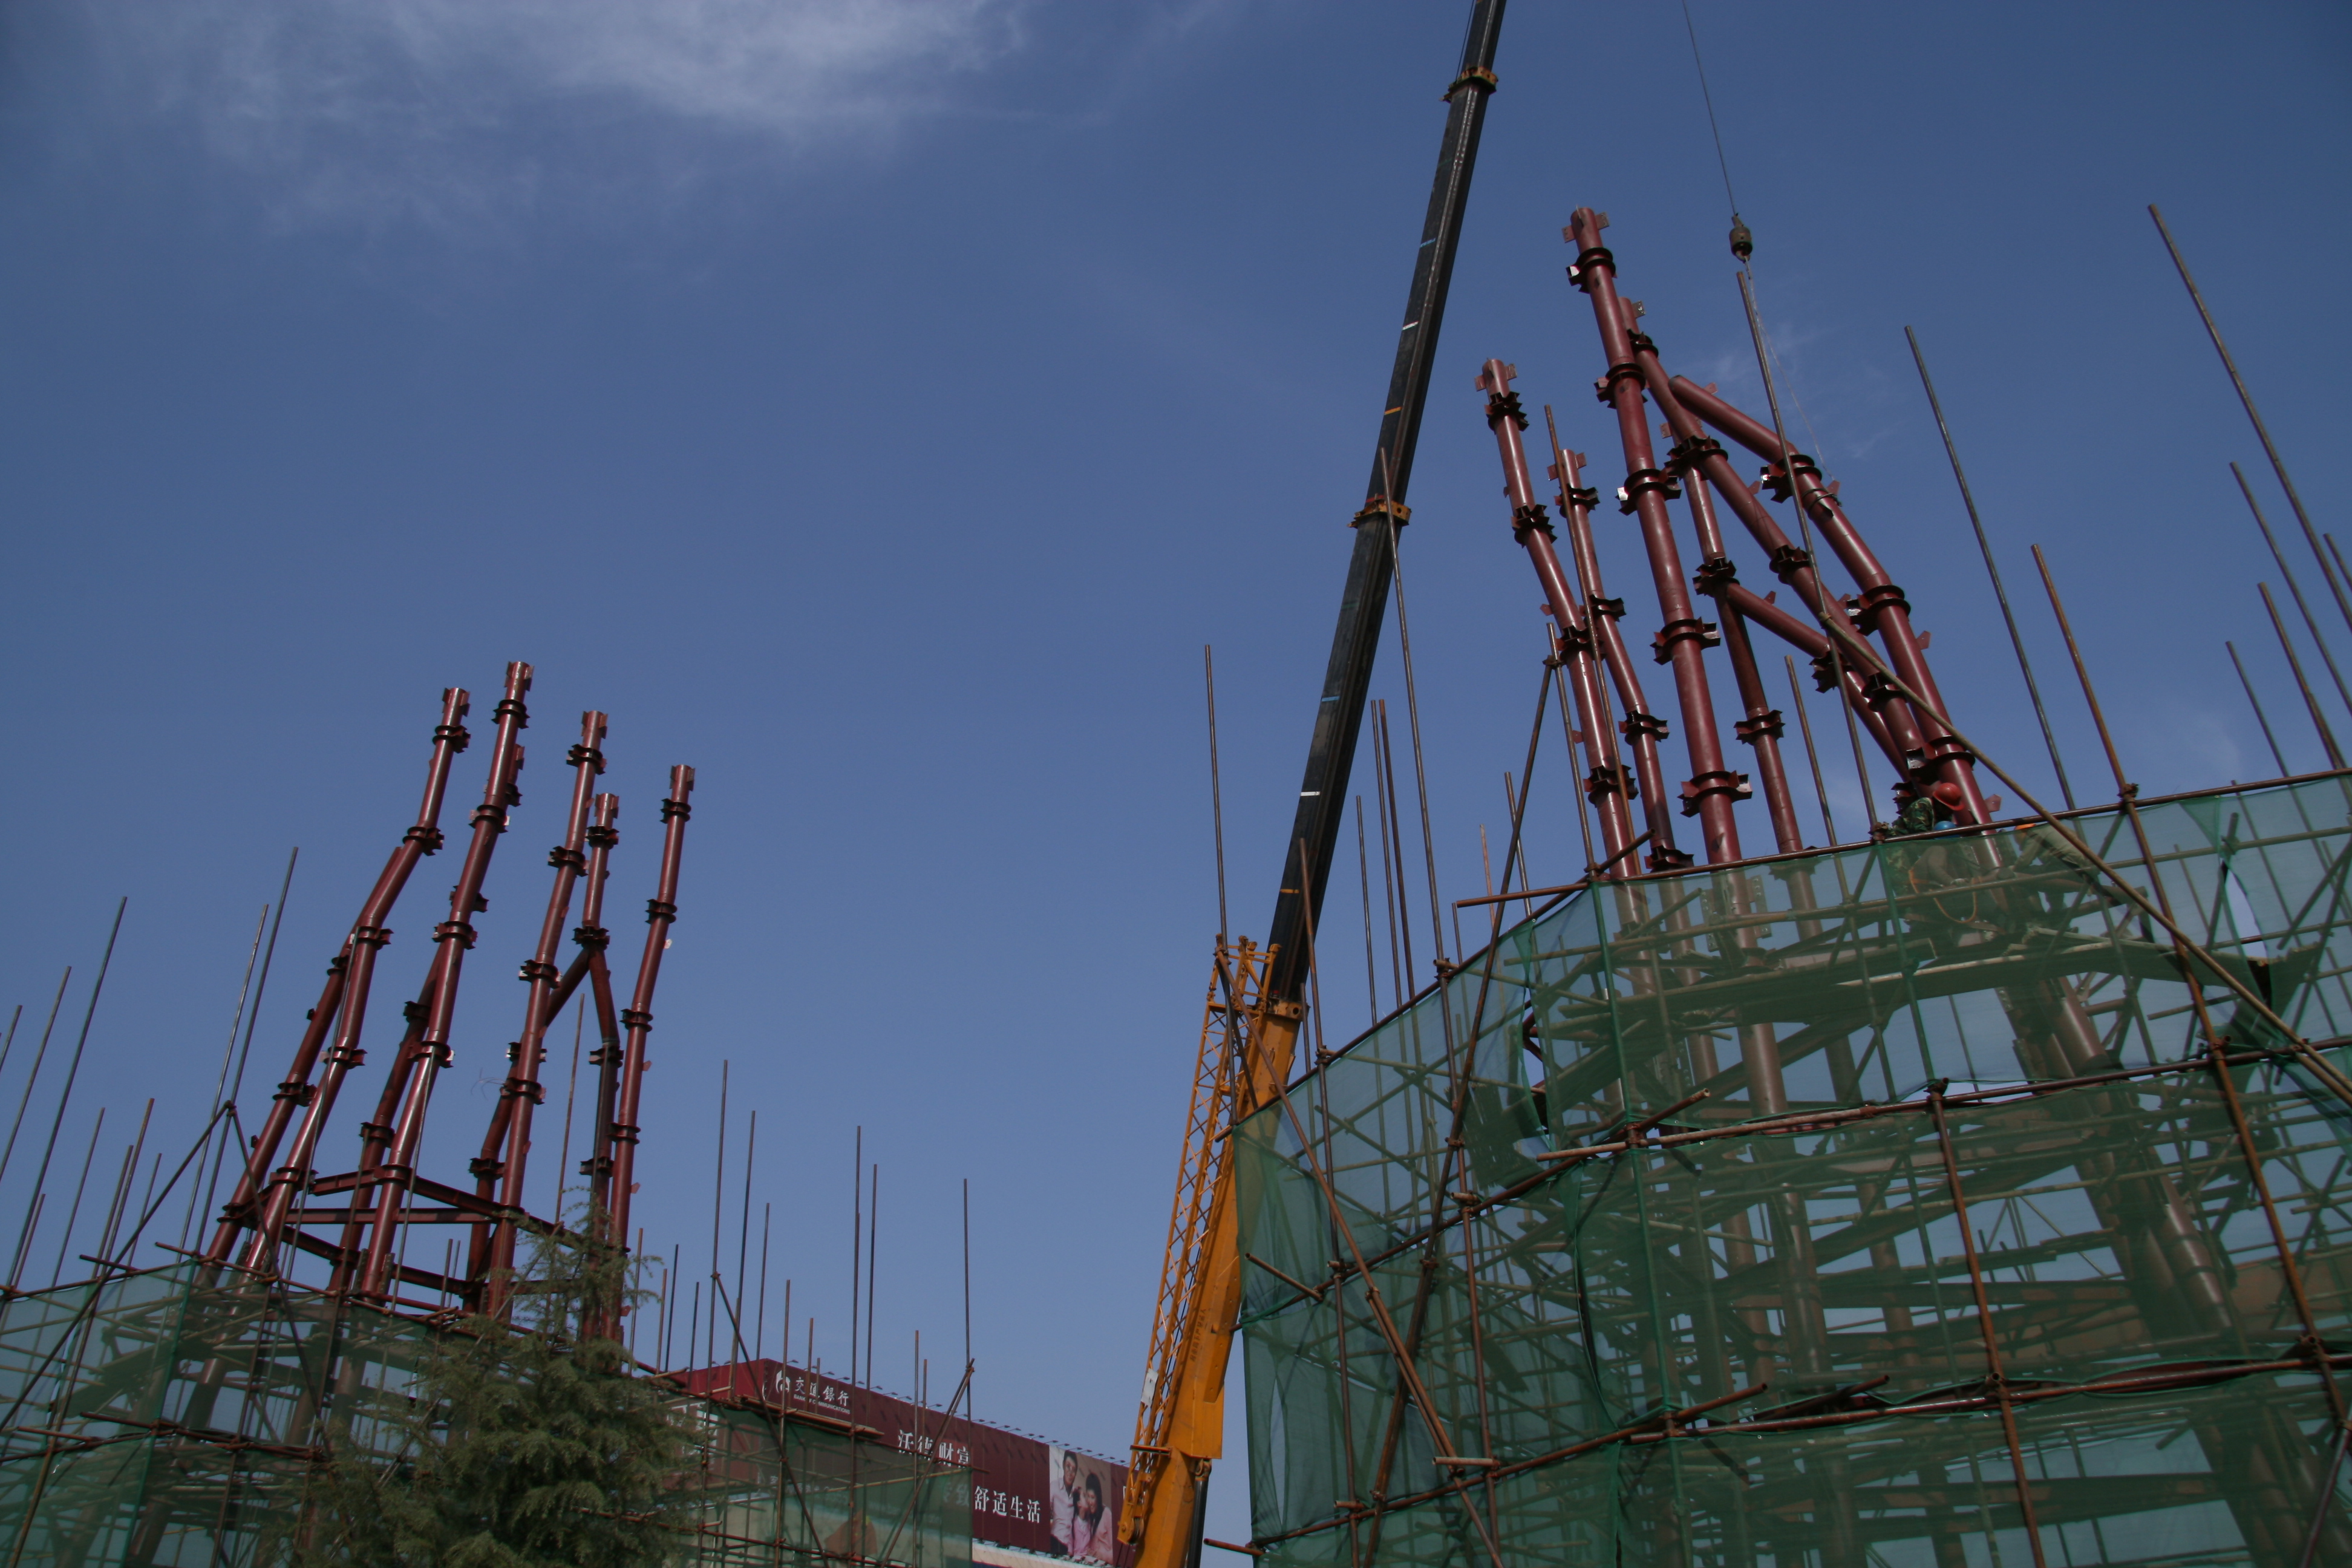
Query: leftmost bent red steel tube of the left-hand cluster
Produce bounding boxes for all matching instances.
[220,687,468,1267]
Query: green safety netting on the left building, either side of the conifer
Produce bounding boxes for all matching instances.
[0,1263,972,1568]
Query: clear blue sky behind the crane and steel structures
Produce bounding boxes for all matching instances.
[0,0,2352,1537]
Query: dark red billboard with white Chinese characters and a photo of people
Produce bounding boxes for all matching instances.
[673,1361,1134,1568]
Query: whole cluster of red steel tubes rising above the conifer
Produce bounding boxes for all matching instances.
[202,663,694,1331]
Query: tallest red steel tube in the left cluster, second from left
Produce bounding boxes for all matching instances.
[350,661,532,1300]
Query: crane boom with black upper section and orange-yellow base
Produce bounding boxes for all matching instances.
[1120,12,1503,1568]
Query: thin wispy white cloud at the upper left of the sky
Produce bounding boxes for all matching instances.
[90,0,1028,226]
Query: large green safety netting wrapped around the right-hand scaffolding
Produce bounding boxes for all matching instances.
[1235,778,2352,1568]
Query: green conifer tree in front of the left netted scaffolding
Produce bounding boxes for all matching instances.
[294,1215,687,1568]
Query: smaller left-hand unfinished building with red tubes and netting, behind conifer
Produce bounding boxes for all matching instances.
[0,663,972,1568]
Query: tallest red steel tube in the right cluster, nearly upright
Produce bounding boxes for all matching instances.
[1569,207,1748,863]
